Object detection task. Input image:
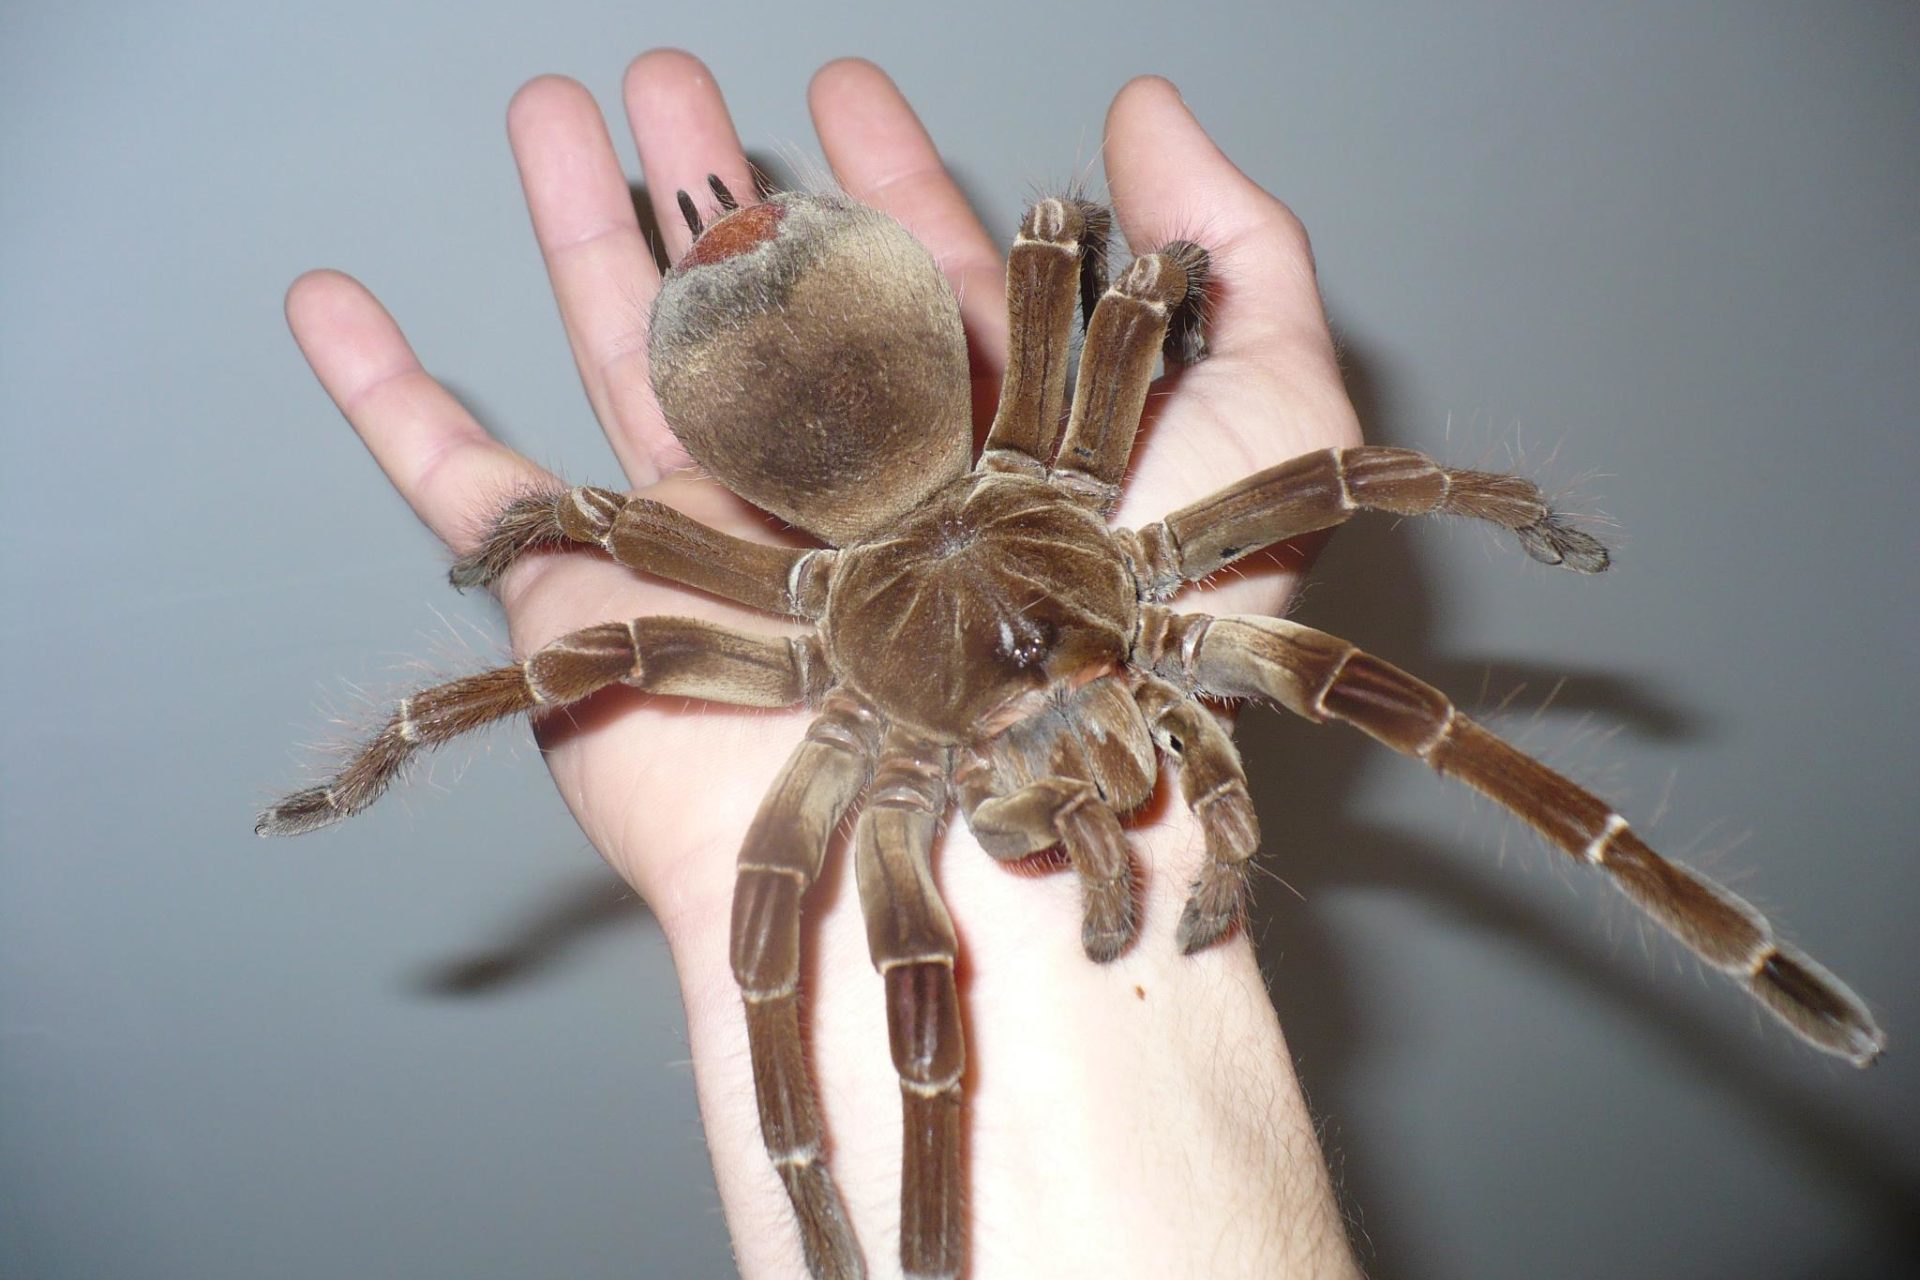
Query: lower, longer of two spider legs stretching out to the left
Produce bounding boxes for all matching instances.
[253,618,828,835]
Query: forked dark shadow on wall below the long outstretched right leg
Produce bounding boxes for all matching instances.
[1240,744,1920,1278]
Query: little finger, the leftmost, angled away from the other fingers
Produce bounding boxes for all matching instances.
[286,271,557,555]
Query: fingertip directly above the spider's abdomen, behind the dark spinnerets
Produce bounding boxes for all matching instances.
[624,48,755,263]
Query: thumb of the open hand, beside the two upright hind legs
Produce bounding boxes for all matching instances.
[1102,75,1332,365]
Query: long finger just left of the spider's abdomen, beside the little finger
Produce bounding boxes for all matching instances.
[507,77,670,486]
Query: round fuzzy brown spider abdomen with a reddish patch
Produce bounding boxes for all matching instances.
[647,194,972,547]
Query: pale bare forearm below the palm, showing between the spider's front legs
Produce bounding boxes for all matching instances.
[662,821,1356,1280]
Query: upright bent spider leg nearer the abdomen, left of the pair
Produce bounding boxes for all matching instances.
[979,198,1112,476]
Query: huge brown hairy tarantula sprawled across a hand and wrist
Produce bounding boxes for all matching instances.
[257,178,1882,1276]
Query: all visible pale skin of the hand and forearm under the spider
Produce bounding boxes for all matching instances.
[286,50,1359,1280]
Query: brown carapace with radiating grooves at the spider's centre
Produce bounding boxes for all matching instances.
[820,474,1139,743]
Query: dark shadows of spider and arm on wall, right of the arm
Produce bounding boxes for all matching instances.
[1236,333,1920,1276]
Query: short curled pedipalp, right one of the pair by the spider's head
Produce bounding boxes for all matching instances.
[1135,676,1260,956]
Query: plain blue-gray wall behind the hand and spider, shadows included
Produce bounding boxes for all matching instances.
[0,2,1920,1280]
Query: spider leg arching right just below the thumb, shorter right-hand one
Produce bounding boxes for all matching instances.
[1135,445,1607,599]
